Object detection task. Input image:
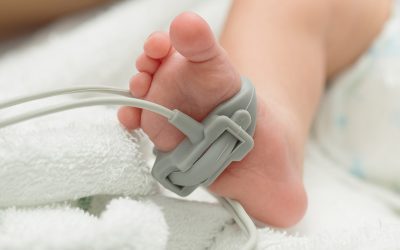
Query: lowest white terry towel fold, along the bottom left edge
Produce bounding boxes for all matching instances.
[0,198,168,250]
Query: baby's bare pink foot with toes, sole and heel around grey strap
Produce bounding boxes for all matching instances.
[118,13,306,226]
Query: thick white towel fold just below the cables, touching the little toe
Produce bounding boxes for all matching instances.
[0,107,157,206]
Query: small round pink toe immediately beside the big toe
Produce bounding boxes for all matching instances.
[143,32,171,59]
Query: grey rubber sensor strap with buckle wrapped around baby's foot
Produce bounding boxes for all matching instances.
[152,77,257,196]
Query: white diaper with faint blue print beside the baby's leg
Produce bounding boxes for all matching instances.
[312,1,400,191]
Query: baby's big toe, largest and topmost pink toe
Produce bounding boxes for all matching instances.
[169,12,221,62]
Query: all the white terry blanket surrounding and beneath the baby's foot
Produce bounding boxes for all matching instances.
[0,0,400,250]
